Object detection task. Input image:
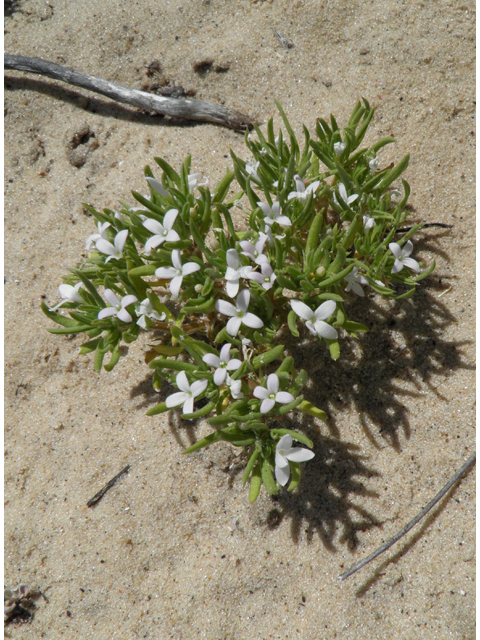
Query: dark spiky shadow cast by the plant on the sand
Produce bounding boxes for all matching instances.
[132,229,473,551]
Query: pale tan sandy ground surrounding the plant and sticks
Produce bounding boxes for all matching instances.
[5,0,475,640]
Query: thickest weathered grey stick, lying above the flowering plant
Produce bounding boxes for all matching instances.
[4,53,257,131]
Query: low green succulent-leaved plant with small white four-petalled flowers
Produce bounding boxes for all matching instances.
[42,100,435,502]
